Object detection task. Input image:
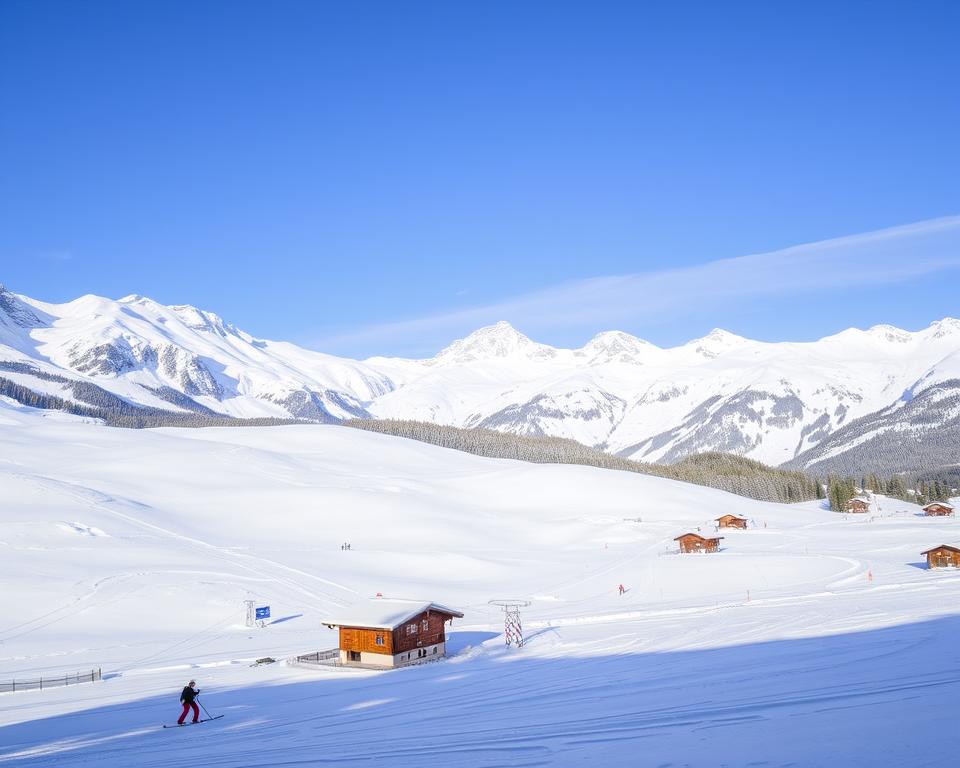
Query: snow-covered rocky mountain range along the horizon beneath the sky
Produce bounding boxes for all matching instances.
[0,289,960,468]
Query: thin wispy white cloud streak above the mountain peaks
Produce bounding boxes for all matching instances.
[314,216,960,351]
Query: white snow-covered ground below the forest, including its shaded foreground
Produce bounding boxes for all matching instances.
[0,400,960,768]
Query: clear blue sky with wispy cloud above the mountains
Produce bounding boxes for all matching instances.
[0,0,960,357]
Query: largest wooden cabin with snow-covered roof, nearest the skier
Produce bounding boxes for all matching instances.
[323,598,463,668]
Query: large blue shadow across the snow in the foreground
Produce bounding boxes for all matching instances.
[0,614,960,768]
